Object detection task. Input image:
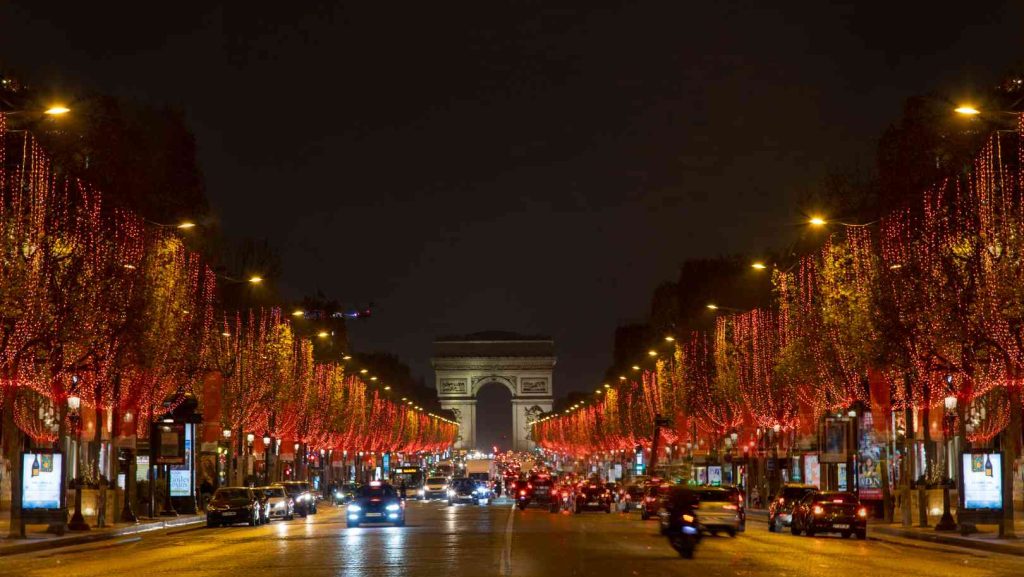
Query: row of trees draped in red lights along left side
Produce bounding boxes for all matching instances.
[0,114,456,528]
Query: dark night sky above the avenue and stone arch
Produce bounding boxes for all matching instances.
[0,1,1024,448]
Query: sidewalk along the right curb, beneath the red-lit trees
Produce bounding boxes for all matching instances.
[746,509,1024,557]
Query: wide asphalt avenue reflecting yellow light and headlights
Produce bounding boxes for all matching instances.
[0,502,1024,577]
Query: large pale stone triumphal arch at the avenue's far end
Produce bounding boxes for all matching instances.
[432,332,555,451]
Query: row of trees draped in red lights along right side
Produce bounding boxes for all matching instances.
[535,119,1024,532]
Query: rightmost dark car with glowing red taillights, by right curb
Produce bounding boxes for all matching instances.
[790,491,867,539]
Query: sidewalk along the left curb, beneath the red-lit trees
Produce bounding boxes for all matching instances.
[0,511,206,558]
